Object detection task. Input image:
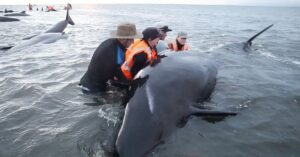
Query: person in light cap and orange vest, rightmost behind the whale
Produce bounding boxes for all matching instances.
[168,32,190,52]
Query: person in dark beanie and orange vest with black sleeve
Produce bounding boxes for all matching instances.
[121,27,160,80]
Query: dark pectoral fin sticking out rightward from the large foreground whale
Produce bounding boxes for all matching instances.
[190,106,237,117]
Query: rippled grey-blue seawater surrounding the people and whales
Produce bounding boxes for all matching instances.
[0,5,300,157]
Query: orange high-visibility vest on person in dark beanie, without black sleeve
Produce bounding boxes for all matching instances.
[121,40,157,80]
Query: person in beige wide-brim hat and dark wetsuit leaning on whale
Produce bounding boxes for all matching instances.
[79,22,143,93]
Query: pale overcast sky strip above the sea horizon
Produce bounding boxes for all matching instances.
[0,0,300,6]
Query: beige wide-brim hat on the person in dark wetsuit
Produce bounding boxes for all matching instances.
[110,22,143,39]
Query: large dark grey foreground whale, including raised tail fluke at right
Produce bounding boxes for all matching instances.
[116,23,271,157]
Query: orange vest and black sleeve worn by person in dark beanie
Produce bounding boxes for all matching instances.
[121,40,157,80]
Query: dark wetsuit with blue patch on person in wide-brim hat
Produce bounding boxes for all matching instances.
[79,39,125,93]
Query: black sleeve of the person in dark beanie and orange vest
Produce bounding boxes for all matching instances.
[131,53,147,76]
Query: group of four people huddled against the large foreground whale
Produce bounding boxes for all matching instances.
[79,22,189,93]
